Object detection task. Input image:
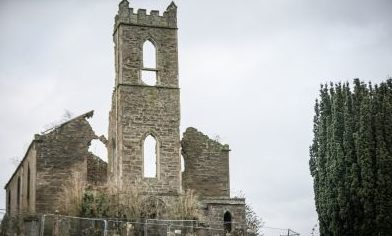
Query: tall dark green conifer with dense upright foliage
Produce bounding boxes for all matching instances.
[309,79,392,235]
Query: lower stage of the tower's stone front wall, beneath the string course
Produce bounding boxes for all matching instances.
[112,87,180,193]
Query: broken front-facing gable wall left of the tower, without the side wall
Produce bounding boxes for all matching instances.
[35,112,107,213]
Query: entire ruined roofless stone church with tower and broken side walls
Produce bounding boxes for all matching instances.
[5,0,245,235]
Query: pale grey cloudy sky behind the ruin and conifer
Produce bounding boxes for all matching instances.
[0,0,392,236]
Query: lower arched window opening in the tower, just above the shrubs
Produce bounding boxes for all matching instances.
[143,135,158,178]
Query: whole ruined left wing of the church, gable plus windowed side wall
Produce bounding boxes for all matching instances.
[5,112,107,217]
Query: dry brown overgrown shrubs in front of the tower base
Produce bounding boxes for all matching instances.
[59,175,202,221]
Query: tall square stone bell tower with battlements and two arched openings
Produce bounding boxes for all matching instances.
[108,0,181,195]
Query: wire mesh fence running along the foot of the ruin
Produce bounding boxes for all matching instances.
[0,214,247,236]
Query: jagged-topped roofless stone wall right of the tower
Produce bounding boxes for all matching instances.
[181,128,230,198]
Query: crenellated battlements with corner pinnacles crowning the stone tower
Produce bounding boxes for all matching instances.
[114,0,177,31]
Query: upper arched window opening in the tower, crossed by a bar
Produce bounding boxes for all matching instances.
[141,40,157,86]
